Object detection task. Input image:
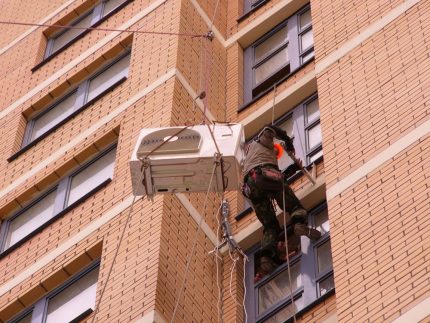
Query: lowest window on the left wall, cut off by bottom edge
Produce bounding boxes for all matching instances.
[9,260,100,323]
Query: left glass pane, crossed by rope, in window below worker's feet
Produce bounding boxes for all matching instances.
[258,262,302,313]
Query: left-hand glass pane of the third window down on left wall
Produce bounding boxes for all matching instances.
[5,191,56,249]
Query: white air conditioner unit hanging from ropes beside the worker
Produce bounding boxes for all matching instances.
[130,123,244,197]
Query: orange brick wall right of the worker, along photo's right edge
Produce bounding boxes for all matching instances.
[312,1,430,322]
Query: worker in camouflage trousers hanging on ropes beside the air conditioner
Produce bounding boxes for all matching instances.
[242,125,321,258]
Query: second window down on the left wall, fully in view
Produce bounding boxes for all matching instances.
[23,51,130,146]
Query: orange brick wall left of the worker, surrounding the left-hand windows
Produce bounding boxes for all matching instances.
[0,0,336,322]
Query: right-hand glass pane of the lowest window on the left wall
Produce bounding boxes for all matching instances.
[46,267,99,323]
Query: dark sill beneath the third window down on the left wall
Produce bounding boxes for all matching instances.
[0,178,112,259]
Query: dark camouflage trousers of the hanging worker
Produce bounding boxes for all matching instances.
[242,167,307,254]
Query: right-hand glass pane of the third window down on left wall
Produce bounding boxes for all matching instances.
[67,149,116,205]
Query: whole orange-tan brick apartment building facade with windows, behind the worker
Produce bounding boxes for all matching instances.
[0,0,430,322]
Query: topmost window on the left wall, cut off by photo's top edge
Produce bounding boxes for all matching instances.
[45,0,130,59]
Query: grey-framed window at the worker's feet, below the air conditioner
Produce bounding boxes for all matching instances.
[246,204,334,322]
